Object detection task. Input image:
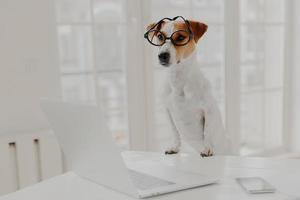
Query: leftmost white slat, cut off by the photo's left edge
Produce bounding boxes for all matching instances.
[0,139,18,195]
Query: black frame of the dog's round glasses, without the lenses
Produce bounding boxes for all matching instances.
[144,16,194,46]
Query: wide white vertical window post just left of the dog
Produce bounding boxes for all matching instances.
[126,0,152,150]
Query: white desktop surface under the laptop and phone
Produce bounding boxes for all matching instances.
[0,152,300,200]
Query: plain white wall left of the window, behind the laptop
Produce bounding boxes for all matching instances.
[0,0,60,134]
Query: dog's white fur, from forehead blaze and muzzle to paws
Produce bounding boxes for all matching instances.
[159,22,231,155]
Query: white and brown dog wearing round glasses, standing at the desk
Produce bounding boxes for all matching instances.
[145,16,231,157]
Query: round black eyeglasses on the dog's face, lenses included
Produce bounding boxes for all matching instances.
[144,16,193,46]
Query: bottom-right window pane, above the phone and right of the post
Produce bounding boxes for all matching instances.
[241,89,283,154]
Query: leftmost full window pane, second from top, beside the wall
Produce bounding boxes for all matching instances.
[58,25,93,72]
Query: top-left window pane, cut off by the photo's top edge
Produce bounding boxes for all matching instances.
[55,0,91,23]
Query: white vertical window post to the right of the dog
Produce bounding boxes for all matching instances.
[224,0,240,154]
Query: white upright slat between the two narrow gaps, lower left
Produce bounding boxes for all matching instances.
[16,136,40,188]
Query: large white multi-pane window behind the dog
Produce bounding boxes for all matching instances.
[56,0,288,155]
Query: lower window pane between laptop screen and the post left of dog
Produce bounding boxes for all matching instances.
[98,73,128,148]
